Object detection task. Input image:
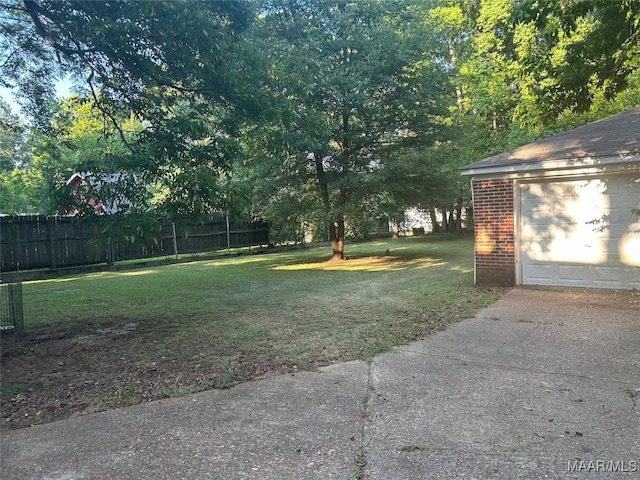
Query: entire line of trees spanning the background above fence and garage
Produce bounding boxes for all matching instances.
[0,0,640,259]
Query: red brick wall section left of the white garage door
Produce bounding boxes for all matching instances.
[473,180,516,286]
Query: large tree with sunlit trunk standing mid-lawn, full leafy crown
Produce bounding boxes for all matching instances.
[245,0,446,259]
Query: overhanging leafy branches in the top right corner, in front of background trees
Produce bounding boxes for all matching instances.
[514,0,640,115]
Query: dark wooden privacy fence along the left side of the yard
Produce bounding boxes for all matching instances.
[0,215,269,272]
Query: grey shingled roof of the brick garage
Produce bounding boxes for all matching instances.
[462,106,640,175]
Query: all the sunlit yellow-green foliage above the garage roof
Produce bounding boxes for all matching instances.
[425,0,640,156]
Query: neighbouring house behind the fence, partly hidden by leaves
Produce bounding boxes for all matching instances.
[67,173,130,215]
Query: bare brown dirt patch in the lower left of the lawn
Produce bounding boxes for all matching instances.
[0,323,297,430]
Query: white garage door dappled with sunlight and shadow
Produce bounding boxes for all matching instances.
[518,175,640,289]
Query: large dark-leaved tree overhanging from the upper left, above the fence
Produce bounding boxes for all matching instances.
[0,0,255,215]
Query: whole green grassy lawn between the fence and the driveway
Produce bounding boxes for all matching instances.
[2,236,498,426]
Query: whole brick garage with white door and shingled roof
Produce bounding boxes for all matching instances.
[462,107,640,289]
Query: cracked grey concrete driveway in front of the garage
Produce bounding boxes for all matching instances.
[0,289,640,480]
